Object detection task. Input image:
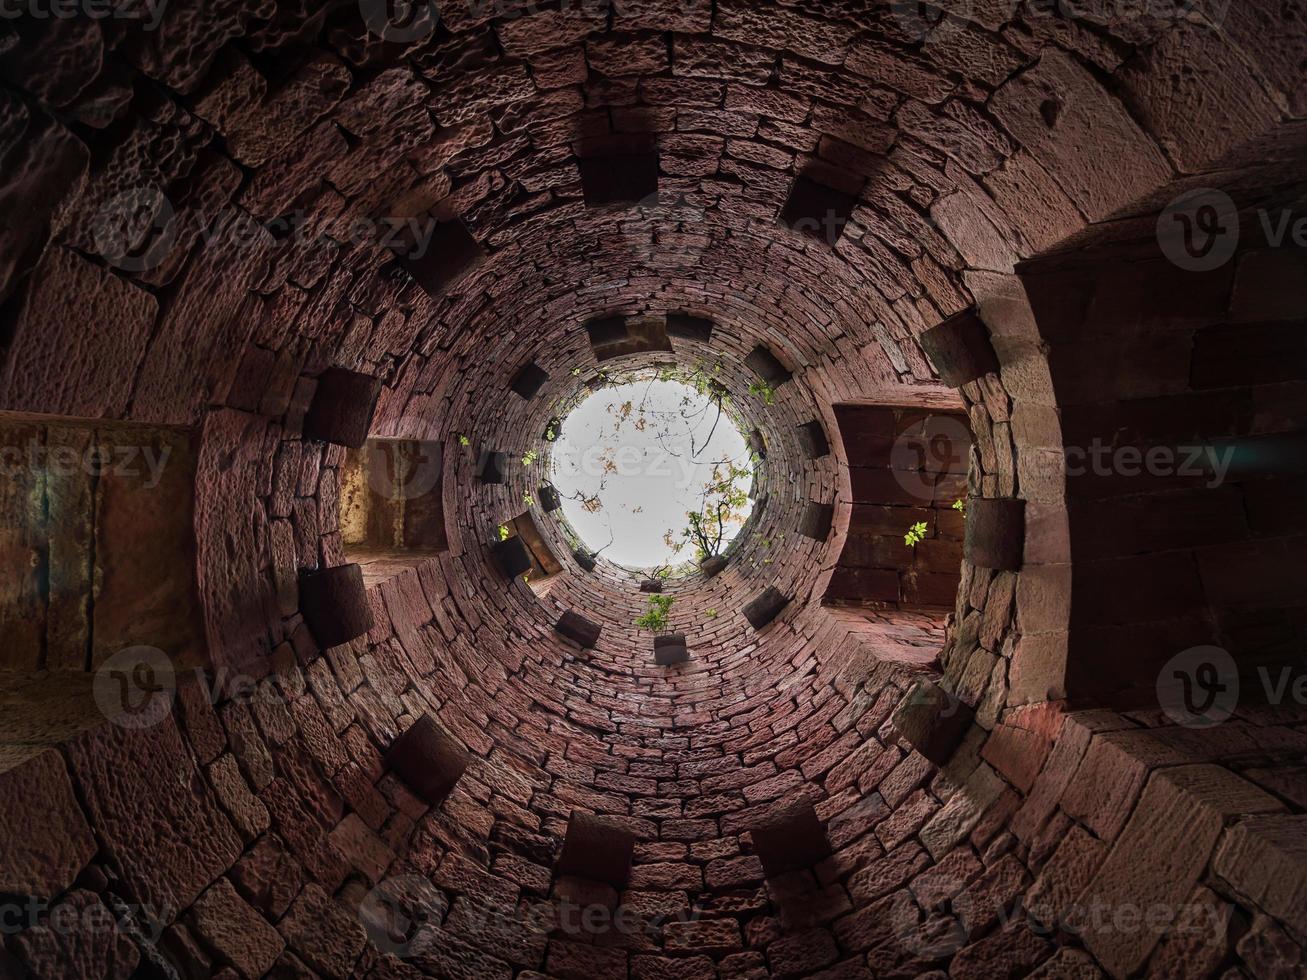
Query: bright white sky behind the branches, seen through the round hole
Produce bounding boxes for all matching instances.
[550,379,753,568]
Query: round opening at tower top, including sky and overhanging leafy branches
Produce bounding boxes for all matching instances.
[550,368,755,572]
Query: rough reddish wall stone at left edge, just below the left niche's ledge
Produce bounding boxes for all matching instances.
[0,746,98,904]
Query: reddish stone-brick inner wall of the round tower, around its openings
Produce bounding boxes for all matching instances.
[0,0,1307,980]
